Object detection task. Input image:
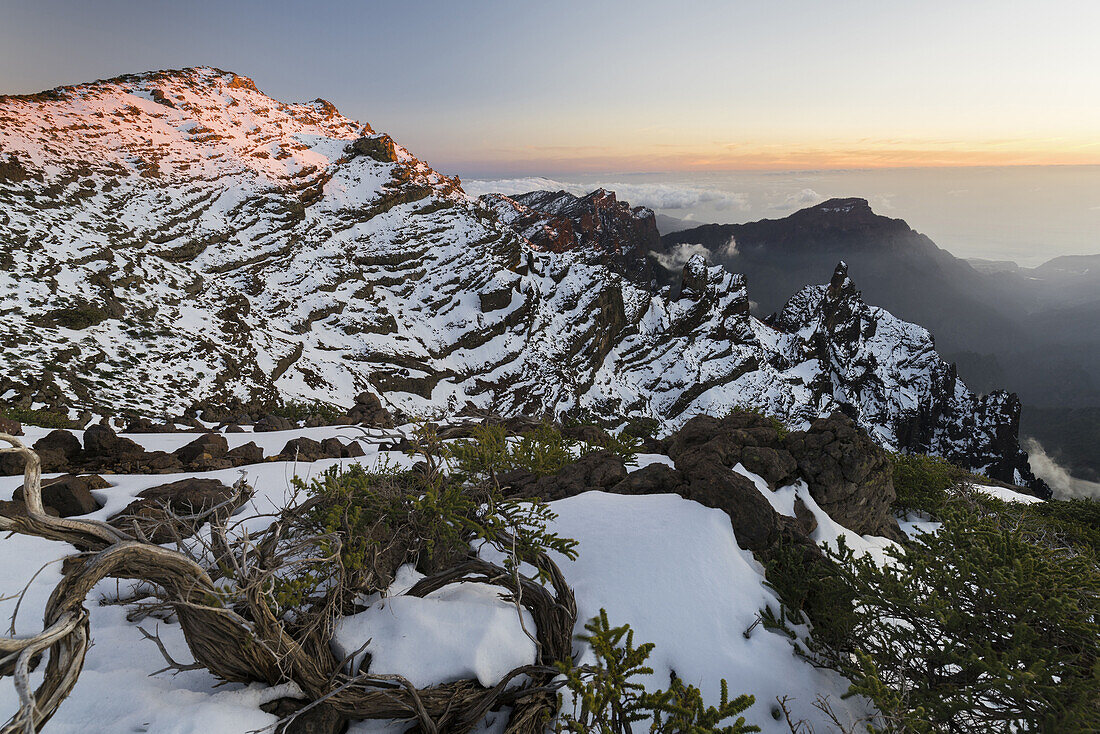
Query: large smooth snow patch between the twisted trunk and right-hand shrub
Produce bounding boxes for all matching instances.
[483,492,860,734]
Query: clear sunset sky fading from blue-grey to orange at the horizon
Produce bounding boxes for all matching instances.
[0,0,1100,177]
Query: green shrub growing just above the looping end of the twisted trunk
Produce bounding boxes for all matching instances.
[272,448,576,610]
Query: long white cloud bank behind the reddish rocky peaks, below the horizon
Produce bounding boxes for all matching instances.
[462,176,748,209]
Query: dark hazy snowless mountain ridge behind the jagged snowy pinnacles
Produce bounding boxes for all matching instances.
[662,198,1100,406]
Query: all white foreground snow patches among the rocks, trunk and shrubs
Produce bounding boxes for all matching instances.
[0,440,881,734]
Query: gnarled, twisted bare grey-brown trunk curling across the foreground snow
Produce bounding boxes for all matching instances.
[0,434,576,734]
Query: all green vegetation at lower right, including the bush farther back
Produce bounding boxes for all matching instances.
[767,457,1100,734]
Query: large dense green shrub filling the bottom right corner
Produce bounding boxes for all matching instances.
[818,494,1100,732]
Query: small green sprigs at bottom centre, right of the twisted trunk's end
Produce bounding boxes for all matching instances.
[556,610,760,734]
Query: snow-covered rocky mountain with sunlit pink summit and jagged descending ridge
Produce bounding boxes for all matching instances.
[0,67,1032,481]
